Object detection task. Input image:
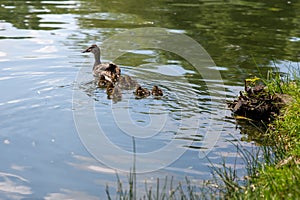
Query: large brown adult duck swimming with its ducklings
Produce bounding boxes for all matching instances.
[82,44,121,83]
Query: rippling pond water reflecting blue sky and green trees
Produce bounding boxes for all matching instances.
[0,0,300,199]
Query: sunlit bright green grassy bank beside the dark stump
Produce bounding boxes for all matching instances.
[247,76,300,199]
